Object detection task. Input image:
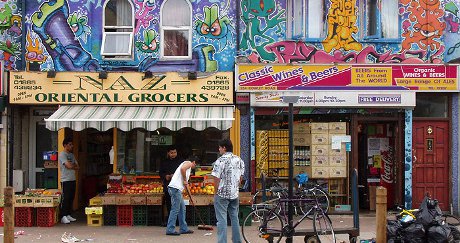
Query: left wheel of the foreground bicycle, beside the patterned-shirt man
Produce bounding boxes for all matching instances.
[241,208,284,243]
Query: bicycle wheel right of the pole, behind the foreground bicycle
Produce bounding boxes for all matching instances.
[299,187,329,219]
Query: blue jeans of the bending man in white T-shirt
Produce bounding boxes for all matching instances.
[166,187,188,234]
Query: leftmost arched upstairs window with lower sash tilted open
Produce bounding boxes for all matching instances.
[101,0,134,59]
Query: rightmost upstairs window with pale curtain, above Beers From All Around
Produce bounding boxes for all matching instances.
[364,0,400,40]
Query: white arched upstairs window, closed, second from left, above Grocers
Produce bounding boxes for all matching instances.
[160,0,192,60]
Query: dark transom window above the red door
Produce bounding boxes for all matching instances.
[413,94,449,118]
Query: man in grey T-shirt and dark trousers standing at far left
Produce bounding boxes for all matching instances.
[59,138,79,224]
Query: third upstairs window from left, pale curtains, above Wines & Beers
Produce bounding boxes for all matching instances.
[288,0,327,40]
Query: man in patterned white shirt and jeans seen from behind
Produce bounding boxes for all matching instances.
[211,139,244,243]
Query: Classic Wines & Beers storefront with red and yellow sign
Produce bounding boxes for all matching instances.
[235,64,458,210]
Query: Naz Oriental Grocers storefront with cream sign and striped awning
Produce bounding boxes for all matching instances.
[9,72,239,208]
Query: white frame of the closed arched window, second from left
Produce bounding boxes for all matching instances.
[160,0,193,61]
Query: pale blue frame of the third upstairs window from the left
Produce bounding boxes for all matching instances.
[286,0,327,42]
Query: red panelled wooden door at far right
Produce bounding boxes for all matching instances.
[412,121,450,211]
